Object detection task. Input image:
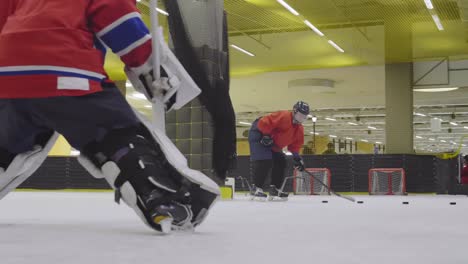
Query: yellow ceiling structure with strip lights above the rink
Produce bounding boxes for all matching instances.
[106,0,468,80]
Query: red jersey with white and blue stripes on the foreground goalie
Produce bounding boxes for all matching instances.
[0,0,151,98]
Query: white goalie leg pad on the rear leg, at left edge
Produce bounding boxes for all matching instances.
[0,132,59,199]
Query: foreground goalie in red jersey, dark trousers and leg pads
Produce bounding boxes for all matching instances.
[0,0,219,233]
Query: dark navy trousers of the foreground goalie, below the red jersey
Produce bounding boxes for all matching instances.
[0,83,139,159]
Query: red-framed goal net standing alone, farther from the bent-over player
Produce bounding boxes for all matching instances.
[369,168,406,195]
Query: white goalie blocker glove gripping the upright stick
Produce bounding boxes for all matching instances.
[125,27,201,111]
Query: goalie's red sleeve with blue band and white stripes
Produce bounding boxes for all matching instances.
[88,0,152,68]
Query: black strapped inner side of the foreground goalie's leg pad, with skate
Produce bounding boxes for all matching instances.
[79,128,193,232]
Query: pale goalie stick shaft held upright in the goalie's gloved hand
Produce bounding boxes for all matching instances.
[149,0,166,132]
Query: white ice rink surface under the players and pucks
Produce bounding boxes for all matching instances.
[0,192,468,264]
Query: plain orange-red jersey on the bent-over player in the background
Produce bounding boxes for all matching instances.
[257,111,304,153]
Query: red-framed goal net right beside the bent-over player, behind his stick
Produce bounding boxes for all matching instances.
[293,168,331,195]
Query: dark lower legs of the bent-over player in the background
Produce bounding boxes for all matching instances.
[250,151,286,189]
